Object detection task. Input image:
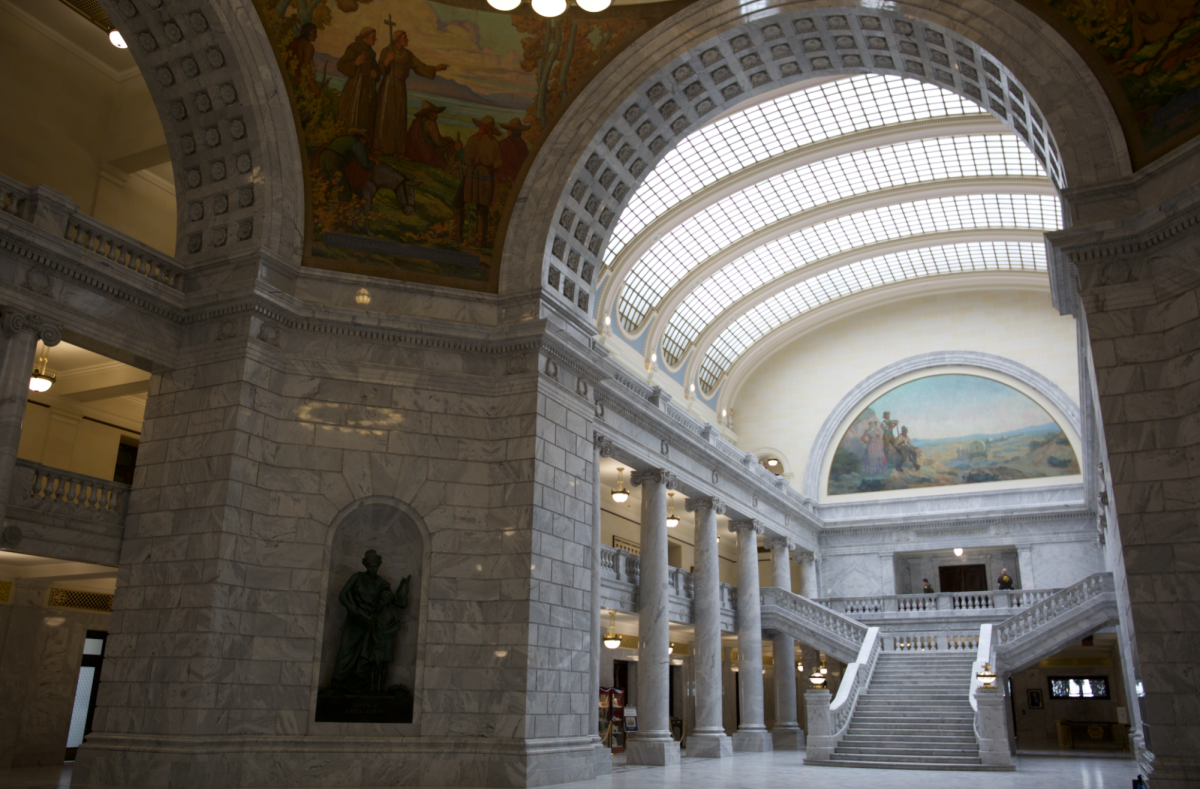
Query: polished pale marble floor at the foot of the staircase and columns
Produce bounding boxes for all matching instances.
[0,752,1138,789]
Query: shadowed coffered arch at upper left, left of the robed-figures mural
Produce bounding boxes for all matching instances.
[100,0,305,272]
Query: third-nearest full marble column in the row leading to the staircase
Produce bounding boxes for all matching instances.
[730,520,772,752]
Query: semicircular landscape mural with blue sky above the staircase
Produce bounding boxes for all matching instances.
[827,375,1080,495]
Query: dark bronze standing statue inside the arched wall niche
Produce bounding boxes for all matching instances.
[328,550,413,693]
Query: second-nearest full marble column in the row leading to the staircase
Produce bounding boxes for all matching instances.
[685,498,733,759]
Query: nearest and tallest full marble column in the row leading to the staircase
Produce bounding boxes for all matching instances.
[625,469,679,766]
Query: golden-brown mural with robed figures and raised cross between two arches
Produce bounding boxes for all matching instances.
[257,0,644,290]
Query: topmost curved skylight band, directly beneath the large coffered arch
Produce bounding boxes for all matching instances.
[605,74,986,264]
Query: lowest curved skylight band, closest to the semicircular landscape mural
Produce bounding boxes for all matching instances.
[700,241,1046,392]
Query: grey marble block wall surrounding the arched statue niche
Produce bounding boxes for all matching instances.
[76,318,594,788]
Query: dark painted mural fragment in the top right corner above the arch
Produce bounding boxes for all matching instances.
[1044,0,1200,159]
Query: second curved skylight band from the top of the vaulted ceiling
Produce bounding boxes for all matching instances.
[618,134,1045,330]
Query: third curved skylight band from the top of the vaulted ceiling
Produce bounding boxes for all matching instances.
[657,194,1062,363]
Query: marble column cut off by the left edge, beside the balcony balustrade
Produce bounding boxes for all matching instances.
[0,308,62,527]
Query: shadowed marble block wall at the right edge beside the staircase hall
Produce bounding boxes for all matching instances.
[1070,199,1200,789]
